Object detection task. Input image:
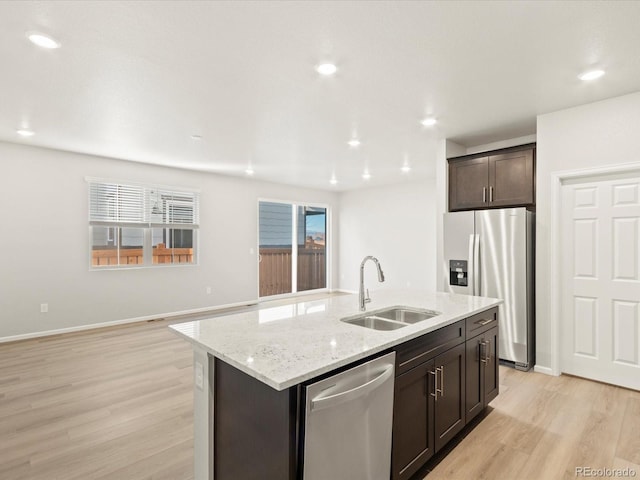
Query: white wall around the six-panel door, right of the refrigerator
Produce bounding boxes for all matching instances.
[536,92,640,369]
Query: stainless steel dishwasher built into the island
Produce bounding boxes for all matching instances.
[303,352,396,480]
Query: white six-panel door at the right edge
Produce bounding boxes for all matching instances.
[560,174,640,389]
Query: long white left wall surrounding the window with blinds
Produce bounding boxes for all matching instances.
[0,142,338,340]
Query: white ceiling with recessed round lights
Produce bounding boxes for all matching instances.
[0,1,640,190]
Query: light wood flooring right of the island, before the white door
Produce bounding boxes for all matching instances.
[423,367,640,480]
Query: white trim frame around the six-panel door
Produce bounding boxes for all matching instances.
[548,162,640,376]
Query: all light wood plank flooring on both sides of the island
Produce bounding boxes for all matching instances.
[0,320,640,480]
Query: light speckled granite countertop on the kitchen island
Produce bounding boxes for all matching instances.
[169,290,502,390]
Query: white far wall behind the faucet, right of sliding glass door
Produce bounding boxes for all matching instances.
[338,180,436,292]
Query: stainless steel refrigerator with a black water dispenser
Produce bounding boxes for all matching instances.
[442,208,535,370]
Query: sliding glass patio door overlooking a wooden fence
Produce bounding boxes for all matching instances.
[258,201,327,297]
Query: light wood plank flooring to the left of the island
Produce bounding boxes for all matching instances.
[0,320,193,480]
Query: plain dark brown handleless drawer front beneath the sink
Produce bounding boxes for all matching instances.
[395,320,465,376]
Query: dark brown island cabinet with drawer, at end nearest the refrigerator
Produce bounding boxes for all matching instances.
[465,309,499,423]
